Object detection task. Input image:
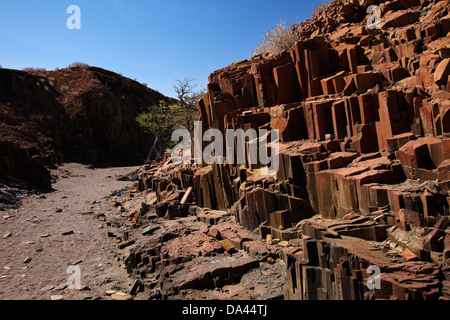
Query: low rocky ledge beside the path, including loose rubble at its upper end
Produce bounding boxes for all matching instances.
[105,192,284,300]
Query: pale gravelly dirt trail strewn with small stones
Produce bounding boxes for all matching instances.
[0,164,137,300]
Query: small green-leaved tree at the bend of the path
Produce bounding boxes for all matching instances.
[136,100,182,162]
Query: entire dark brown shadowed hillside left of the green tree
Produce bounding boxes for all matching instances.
[0,67,171,186]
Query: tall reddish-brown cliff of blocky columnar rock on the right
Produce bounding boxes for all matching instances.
[139,0,450,300]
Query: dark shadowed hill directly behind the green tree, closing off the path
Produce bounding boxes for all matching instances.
[46,67,174,164]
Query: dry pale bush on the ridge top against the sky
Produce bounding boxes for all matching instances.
[252,21,299,56]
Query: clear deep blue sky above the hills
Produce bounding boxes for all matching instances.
[0,0,320,96]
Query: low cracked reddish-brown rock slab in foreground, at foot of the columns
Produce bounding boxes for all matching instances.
[120,212,283,299]
